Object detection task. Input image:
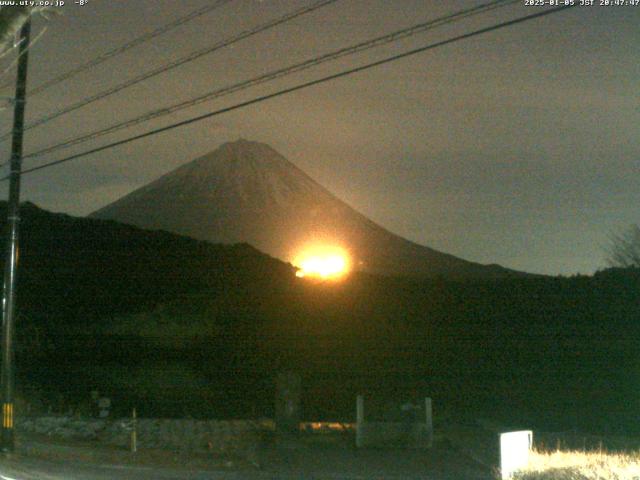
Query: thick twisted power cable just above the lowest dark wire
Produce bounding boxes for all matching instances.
[25,0,520,162]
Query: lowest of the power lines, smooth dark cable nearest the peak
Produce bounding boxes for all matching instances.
[0,5,575,181]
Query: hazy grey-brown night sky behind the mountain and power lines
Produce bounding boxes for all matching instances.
[0,0,640,274]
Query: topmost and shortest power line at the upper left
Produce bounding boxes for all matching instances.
[1,0,233,96]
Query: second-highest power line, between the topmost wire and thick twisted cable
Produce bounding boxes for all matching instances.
[0,0,338,141]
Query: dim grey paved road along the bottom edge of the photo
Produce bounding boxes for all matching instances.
[0,449,494,480]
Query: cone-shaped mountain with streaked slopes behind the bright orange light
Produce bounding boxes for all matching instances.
[92,140,510,277]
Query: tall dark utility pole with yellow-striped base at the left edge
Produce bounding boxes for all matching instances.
[0,20,31,453]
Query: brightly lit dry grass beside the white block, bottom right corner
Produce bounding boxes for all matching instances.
[513,451,640,480]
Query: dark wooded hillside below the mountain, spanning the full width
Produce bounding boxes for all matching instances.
[0,205,640,433]
